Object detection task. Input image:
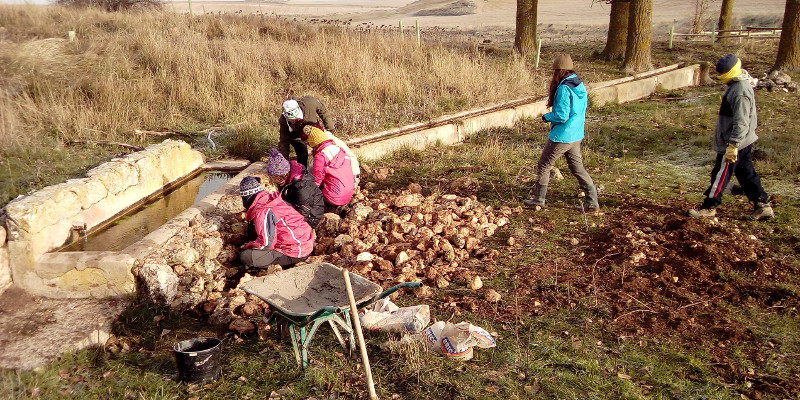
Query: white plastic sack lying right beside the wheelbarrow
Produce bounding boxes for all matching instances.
[359,298,431,333]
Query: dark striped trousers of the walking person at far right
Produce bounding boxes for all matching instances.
[701,144,768,208]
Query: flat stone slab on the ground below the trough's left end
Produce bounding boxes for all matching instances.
[0,286,128,370]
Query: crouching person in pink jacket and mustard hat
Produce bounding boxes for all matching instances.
[303,125,356,214]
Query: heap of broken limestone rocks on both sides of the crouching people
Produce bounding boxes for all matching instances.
[134,183,522,333]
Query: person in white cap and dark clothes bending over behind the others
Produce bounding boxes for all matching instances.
[277,96,334,167]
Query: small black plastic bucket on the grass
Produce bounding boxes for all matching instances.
[172,337,222,383]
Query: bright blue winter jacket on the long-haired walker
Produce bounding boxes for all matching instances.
[544,74,587,143]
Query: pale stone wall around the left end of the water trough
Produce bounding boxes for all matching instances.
[0,140,203,297]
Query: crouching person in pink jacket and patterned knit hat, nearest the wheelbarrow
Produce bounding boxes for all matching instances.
[239,176,315,268]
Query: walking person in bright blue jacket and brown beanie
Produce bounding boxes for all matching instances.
[523,54,600,212]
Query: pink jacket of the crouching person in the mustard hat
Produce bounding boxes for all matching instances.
[311,140,355,206]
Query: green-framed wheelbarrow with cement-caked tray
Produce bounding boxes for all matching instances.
[241,263,420,368]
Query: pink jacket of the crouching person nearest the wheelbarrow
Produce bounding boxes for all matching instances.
[244,191,315,258]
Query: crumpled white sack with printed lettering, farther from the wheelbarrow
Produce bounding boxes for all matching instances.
[422,321,497,361]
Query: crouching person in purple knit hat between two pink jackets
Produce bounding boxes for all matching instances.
[266,149,325,228]
